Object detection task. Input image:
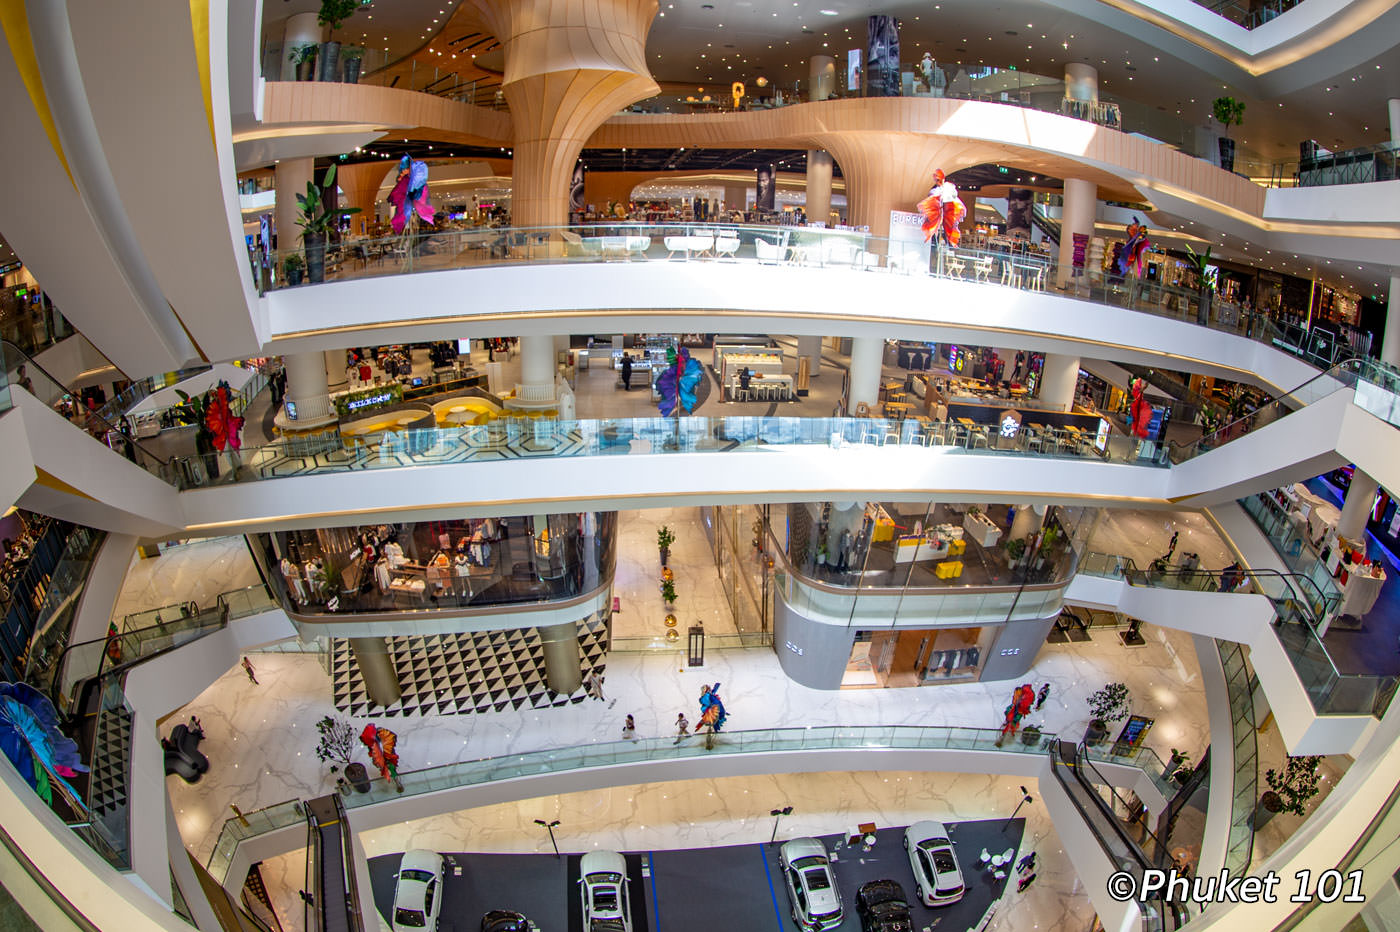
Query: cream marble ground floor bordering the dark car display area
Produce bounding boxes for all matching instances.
[262,772,1093,932]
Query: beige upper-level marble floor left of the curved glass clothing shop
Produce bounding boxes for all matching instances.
[112,537,262,628]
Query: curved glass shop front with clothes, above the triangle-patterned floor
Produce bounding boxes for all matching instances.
[248,511,617,614]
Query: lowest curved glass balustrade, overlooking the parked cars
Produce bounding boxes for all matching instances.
[209,725,1163,882]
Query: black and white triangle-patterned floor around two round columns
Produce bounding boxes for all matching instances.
[330,623,608,718]
